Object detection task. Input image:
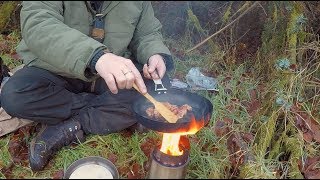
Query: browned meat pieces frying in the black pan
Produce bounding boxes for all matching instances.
[146,102,192,119]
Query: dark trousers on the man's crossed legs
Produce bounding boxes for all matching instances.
[1,67,170,134]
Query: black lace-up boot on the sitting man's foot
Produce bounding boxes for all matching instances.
[29,120,85,171]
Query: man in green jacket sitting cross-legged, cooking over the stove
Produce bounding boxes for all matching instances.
[1,1,173,171]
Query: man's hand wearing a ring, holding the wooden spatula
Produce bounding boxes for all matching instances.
[95,53,147,94]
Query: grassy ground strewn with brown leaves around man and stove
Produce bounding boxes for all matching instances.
[0,2,320,179]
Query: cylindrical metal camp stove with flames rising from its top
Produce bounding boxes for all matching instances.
[148,115,205,179]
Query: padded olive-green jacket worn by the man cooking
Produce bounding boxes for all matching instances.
[17,1,170,81]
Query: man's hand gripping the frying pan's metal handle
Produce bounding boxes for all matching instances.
[143,54,166,79]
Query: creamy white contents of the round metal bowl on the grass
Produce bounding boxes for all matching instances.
[69,164,113,179]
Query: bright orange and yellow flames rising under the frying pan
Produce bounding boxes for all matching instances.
[160,117,204,156]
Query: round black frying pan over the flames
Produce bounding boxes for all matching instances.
[133,89,213,133]
